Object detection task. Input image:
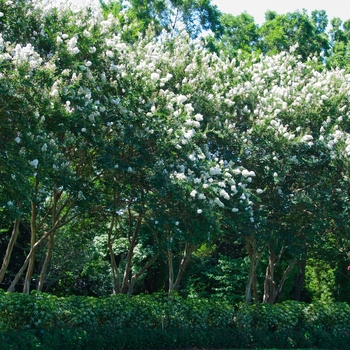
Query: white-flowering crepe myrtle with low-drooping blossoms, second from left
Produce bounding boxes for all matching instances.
[79,22,254,293]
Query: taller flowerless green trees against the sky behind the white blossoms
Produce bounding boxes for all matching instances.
[100,0,350,70]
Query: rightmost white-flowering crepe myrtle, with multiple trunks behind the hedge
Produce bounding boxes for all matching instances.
[211,46,349,302]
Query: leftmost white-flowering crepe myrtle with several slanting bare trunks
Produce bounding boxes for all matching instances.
[1,2,112,292]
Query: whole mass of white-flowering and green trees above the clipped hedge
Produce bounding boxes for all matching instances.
[0,0,350,304]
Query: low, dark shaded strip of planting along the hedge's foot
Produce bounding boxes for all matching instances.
[0,327,349,350]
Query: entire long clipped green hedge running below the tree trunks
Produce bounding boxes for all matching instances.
[0,291,350,350]
